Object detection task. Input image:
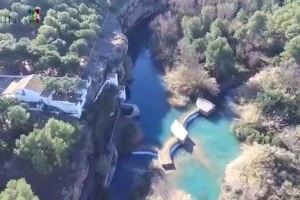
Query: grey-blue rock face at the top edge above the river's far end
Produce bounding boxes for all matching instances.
[119,0,167,32]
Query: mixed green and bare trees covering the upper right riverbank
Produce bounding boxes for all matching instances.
[152,0,300,105]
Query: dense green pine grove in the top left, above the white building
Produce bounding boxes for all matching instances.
[0,0,104,75]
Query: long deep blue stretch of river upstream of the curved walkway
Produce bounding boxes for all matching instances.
[128,24,170,146]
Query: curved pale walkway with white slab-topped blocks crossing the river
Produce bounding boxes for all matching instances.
[133,98,215,171]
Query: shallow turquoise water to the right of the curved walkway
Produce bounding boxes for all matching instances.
[170,113,239,200]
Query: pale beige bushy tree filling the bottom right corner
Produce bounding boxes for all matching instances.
[220,145,300,200]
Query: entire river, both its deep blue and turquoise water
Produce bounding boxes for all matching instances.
[110,23,239,200]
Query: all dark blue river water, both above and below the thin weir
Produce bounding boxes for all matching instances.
[109,23,170,200]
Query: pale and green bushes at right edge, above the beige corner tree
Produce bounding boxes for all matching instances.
[235,63,300,146]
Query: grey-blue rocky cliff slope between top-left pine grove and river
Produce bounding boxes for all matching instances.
[84,12,128,99]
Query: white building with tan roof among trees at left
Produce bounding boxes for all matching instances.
[1,75,90,118]
